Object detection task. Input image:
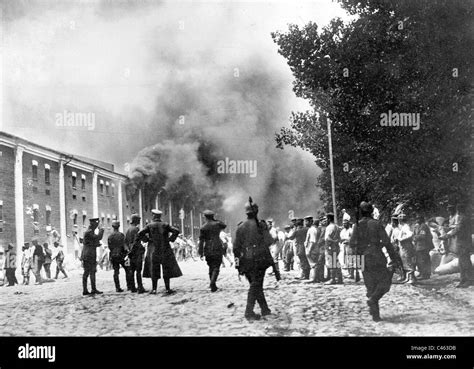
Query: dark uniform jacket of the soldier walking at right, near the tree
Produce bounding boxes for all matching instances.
[349,217,401,268]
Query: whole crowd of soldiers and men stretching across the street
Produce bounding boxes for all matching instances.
[1,198,474,321]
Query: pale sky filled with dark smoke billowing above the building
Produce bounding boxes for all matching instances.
[2,1,348,224]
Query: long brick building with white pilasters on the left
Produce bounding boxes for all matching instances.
[0,132,141,255]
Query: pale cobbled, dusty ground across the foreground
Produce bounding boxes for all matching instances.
[0,261,474,336]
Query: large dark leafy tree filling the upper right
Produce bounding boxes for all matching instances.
[272,0,474,215]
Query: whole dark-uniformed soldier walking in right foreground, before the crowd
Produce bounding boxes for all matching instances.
[349,201,401,322]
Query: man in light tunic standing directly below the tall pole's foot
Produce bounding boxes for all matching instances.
[324,213,343,284]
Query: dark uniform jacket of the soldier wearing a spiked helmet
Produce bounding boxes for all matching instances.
[233,219,273,274]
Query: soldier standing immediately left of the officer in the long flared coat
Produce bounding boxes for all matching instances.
[125,214,146,293]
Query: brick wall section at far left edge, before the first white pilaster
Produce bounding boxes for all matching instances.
[0,145,16,247]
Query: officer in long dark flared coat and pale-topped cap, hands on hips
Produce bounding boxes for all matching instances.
[138,209,183,295]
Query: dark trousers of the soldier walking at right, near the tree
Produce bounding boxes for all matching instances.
[362,265,393,317]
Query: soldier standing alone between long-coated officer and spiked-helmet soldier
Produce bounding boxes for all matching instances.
[198,210,227,292]
